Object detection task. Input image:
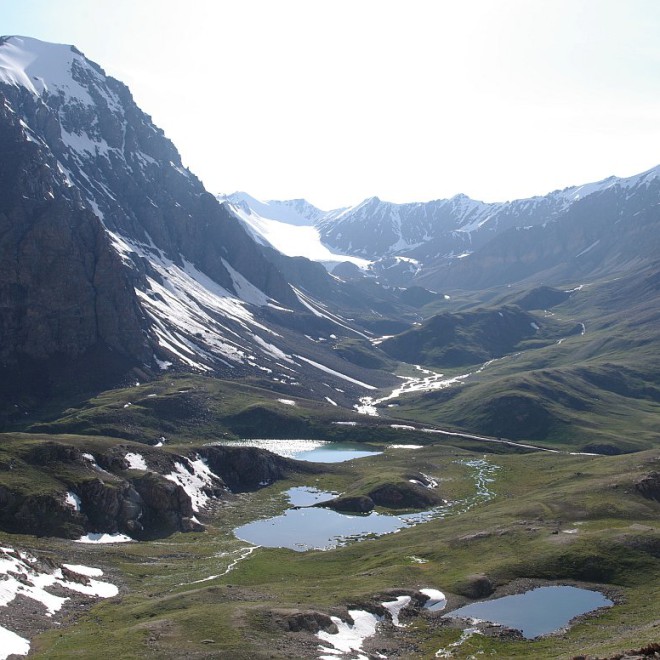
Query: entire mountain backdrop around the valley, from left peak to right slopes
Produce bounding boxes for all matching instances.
[0,37,660,451]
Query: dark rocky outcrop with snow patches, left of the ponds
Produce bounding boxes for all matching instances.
[0,440,318,539]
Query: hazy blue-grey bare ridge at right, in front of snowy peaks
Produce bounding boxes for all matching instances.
[419,175,660,289]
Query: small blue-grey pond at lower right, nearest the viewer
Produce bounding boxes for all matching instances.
[445,586,614,639]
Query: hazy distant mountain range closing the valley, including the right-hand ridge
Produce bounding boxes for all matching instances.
[223,166,660,290]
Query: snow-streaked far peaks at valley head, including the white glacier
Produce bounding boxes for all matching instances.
[231,160,660,286]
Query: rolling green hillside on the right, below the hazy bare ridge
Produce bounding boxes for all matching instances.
[376,272,660,452]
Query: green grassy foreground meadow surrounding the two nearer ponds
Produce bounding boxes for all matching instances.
[23,444,660,658]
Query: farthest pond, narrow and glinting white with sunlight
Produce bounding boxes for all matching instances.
[217,439,383,463]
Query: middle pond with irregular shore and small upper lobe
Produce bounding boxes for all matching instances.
[234,486,447,552]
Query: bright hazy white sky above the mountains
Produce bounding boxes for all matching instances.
[0,0,660,209]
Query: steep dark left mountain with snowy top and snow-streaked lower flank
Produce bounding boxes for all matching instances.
[0,37,316,387]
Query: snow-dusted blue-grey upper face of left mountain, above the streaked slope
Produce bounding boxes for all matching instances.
[0,37,293,301]
